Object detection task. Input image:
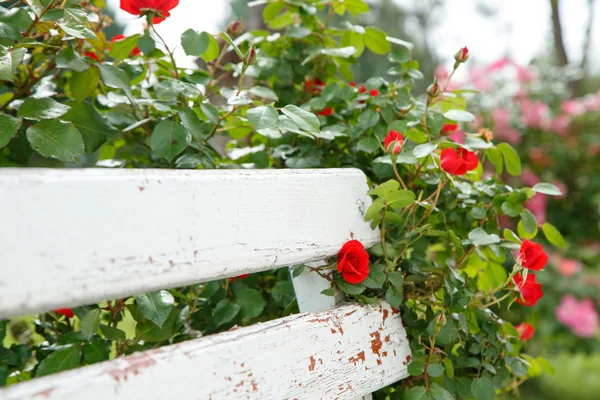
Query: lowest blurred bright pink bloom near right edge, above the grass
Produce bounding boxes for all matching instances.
[554,295,598,338]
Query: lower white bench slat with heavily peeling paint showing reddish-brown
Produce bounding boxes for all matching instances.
[0,303,410,400]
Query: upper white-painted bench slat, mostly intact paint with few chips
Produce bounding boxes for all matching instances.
[0,169,378,319]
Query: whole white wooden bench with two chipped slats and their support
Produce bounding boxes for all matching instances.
[0,169,410,400]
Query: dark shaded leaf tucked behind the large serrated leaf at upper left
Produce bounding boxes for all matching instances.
[62,103,118,153]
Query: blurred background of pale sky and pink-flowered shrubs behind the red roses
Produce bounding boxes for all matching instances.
[107,0,600,400]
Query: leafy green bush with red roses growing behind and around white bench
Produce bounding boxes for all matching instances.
[0,0,563,400]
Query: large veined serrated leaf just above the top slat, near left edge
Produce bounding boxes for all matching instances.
[27,119,83,164]
